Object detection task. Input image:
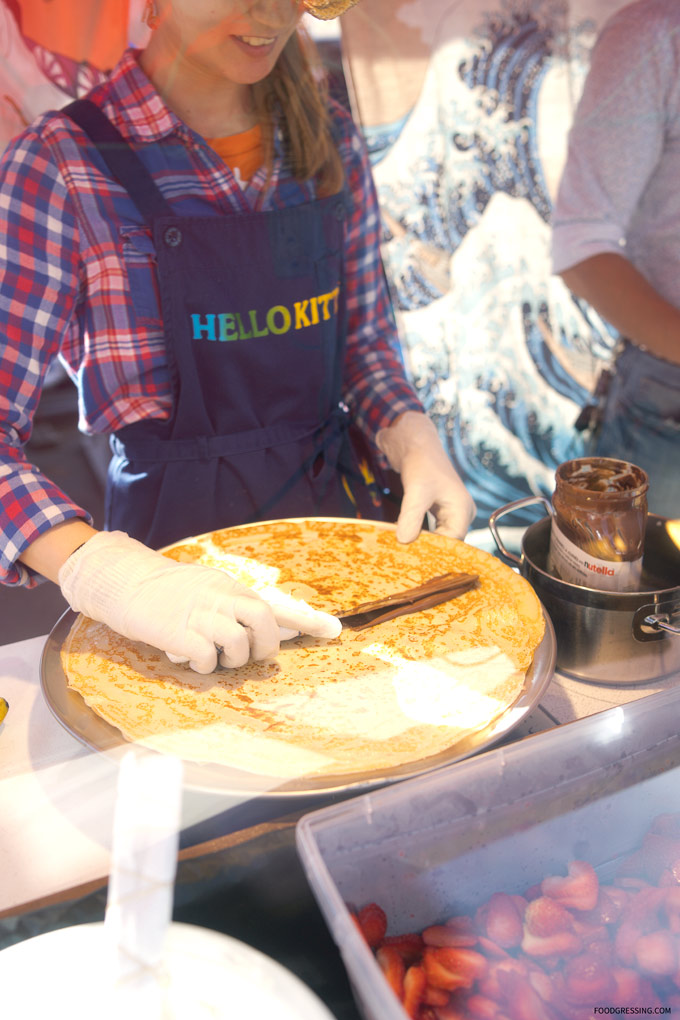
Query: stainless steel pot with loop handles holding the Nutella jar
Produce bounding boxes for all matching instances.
[488,496,680,686]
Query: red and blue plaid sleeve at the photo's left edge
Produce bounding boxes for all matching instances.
[0,131,89,588]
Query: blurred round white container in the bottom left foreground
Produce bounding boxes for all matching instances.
[0,923,333,1020]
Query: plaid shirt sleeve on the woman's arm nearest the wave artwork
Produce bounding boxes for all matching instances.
[339,107,423,440]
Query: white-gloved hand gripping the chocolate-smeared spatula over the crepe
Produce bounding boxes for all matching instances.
[59,531,342,673]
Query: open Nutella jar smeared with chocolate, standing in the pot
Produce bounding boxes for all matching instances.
[547,457,648,592]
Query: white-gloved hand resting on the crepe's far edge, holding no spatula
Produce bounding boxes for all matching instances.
[376,411,476,543]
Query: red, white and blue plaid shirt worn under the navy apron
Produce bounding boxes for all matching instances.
[0,51,422,585]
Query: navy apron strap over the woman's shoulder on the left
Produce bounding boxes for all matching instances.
[60,99,174,220]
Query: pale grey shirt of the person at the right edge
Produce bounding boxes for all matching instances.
[553,0,680,308]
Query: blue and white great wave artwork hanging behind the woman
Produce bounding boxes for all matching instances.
[366,0,616,527]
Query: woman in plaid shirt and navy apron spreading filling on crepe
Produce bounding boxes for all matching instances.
[0,0,472,672]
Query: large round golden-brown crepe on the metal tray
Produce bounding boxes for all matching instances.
[61,519,543,777]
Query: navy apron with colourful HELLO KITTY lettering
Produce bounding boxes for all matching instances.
[63,100,380,548]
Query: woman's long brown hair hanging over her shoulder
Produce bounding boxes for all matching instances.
[254,31,345,196]
